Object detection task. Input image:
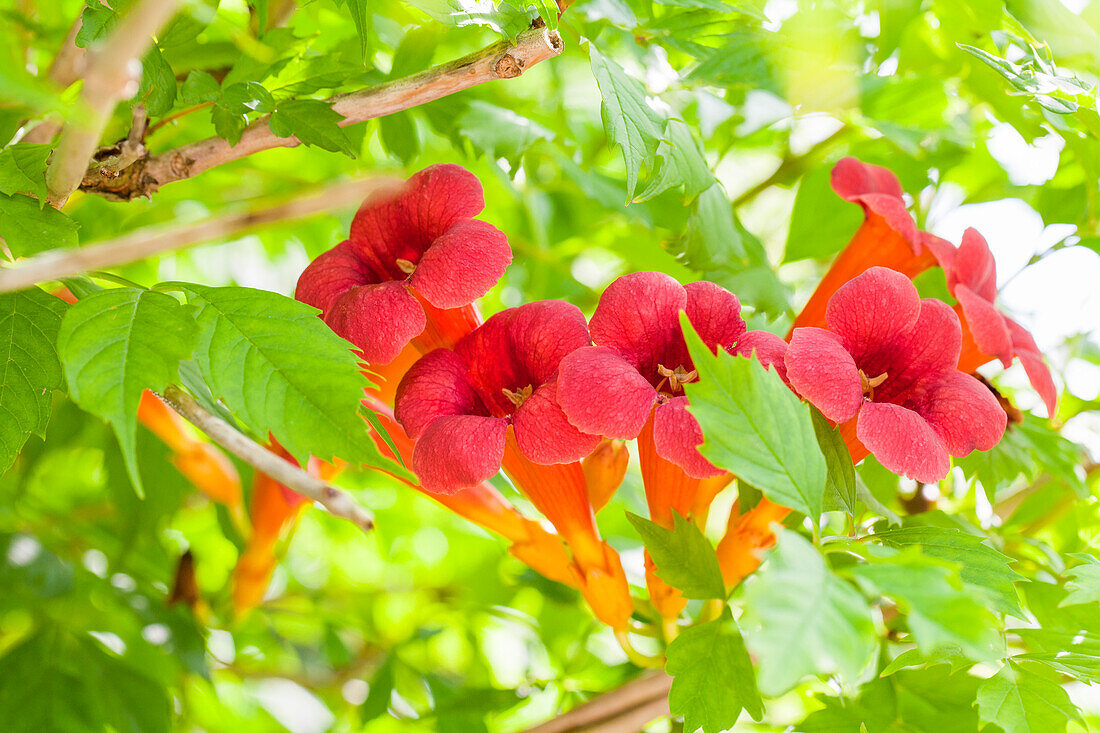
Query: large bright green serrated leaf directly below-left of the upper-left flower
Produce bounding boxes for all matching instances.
[179,284,396,468]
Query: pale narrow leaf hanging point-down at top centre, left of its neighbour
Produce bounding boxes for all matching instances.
[589,43,664,198]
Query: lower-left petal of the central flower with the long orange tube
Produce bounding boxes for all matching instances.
[413,415,508,494]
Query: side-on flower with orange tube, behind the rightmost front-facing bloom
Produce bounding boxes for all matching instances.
[789,157,936,336]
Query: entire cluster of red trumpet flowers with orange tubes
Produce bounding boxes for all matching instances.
[279,158,1055,631]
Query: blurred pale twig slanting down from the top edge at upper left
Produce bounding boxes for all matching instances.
[46,0,179,207]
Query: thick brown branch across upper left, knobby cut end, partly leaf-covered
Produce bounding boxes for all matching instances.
[81,29,564,200]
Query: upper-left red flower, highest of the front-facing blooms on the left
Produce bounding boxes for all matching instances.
[295,164,512,364]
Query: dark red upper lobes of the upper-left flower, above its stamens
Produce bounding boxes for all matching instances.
[351,164,485,280]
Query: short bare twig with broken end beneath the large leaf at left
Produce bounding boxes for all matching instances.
[161,384,374,532]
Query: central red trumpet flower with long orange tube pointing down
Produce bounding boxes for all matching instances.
[394,300,633,628]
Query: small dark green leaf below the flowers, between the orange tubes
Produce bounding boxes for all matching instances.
[626,512,726,599]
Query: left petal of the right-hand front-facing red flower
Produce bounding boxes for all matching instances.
[784,328,864,423]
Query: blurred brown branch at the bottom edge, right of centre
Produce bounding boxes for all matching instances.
[527,671,672,733]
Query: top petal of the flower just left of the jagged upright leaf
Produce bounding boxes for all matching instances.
[589,272,688,367]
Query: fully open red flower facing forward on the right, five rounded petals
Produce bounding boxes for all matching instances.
[784,267,1007,483]
